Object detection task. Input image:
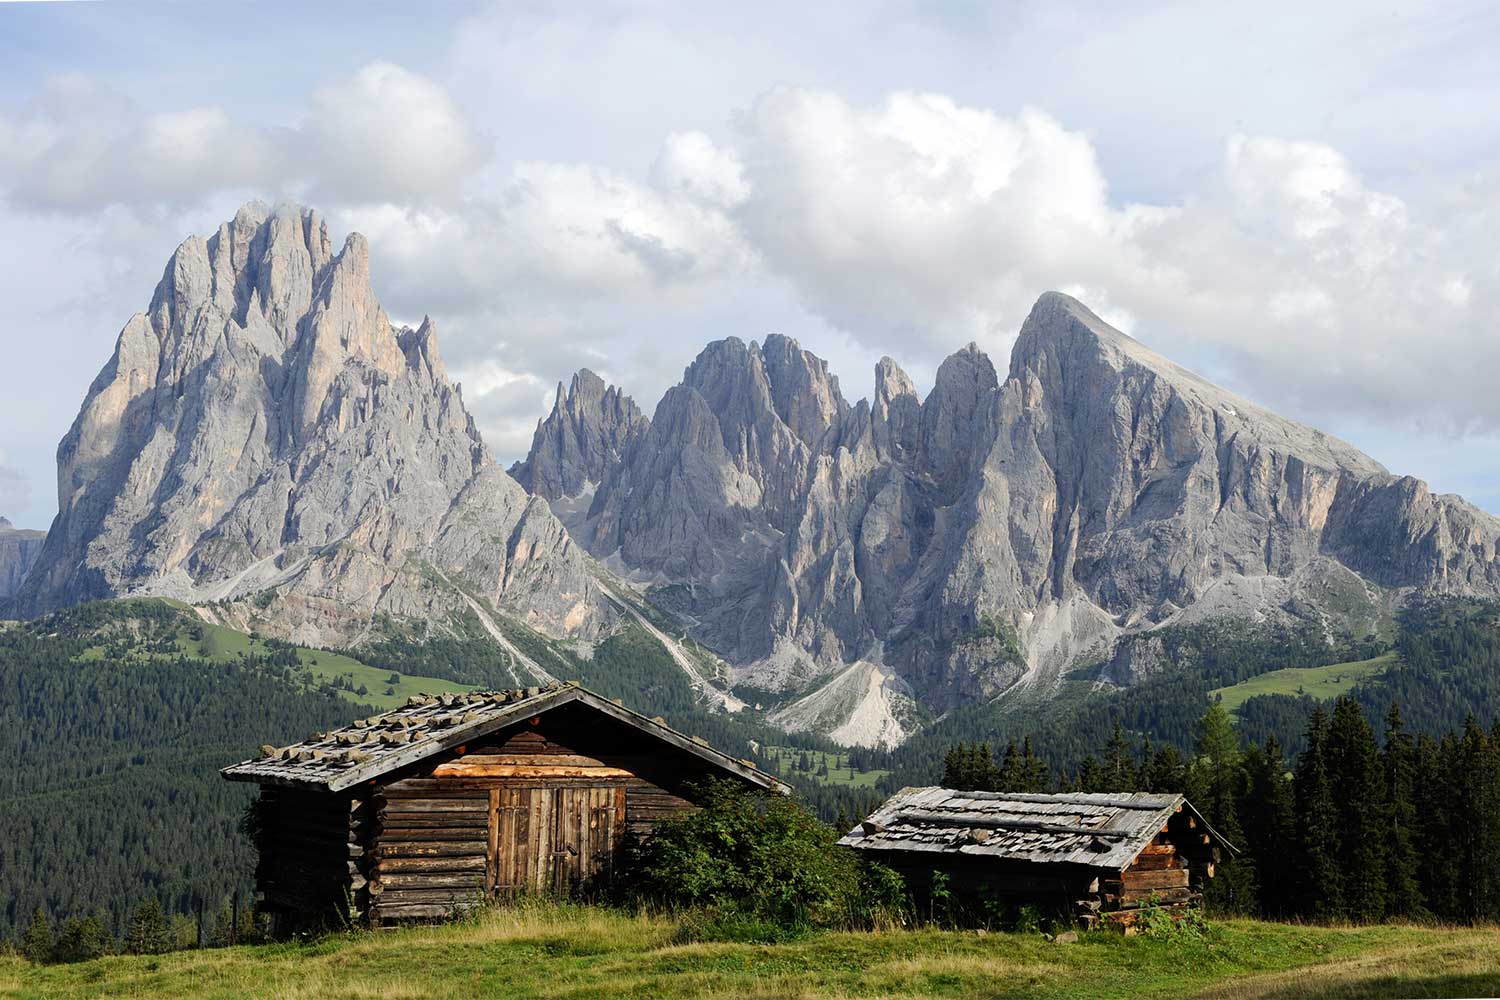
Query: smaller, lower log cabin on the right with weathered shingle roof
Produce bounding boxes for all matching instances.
[839,787,1238,928]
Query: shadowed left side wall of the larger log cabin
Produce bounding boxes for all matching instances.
[255,786,368,931]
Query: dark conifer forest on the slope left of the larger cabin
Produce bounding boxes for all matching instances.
[0,601,363,951]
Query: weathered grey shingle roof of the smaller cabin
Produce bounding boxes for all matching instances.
[839,786,1235,868]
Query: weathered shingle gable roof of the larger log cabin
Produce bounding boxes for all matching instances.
[219,684,791,793]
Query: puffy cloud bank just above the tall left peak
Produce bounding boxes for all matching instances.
[0,63,489,213]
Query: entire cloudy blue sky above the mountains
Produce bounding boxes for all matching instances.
[0,1,1500,528]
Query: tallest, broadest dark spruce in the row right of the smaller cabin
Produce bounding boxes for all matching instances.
[1326,697,1386,924]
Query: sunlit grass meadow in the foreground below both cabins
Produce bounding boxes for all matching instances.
[0,904,1500,1000]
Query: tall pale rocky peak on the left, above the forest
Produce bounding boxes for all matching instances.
[12,202,611,656]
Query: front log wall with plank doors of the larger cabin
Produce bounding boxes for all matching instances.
[366,706,710,922]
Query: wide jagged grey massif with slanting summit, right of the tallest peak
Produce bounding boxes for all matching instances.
[528,292,1500,744]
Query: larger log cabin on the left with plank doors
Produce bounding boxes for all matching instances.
[222,684,789,930]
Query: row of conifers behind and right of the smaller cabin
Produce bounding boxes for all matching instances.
[942,697,1500,922]
